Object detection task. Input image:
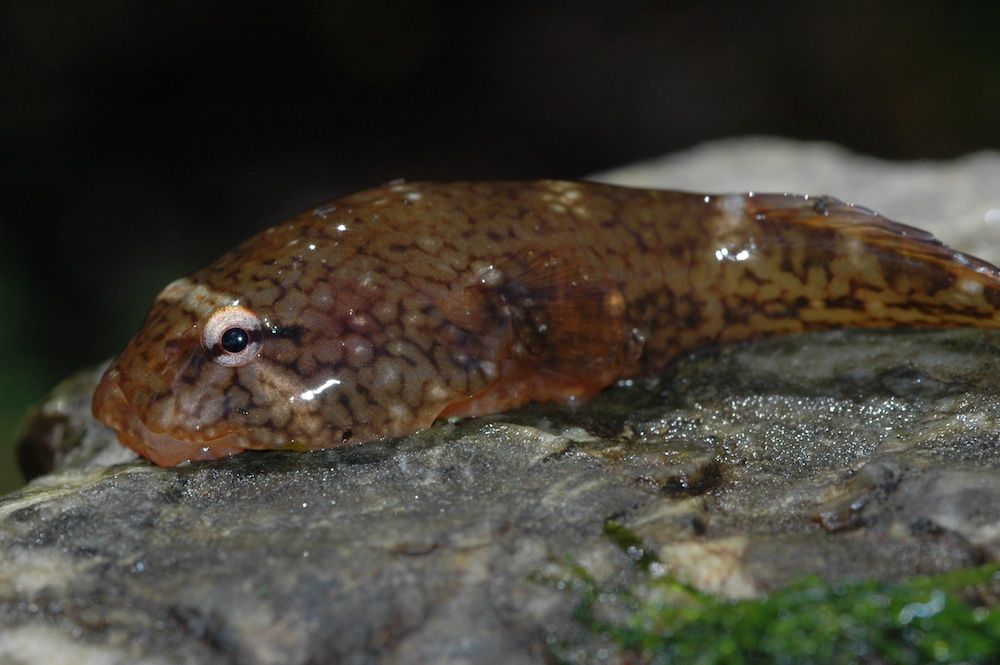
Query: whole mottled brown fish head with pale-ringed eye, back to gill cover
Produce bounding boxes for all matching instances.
[93,215,495,466]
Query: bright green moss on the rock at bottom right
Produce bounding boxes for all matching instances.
[567,522,1000,664]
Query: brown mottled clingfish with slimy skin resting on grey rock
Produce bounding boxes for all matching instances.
[93,181,1000,466]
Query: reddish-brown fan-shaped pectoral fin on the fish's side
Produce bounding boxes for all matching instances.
[441,241,628,415]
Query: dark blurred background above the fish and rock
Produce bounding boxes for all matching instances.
[0,0,1000,491]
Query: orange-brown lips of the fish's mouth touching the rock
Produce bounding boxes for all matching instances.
[91,367,246,466]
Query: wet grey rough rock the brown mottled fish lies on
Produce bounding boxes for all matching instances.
[0,139,1000,664]
